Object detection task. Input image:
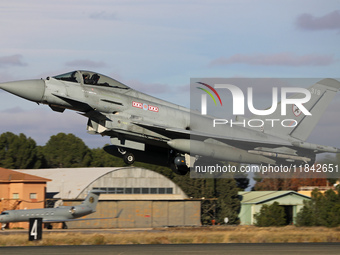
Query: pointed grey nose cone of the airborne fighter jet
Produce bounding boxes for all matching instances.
[0,80,45,102]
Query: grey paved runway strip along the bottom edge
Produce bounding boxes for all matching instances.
[0,243,340,255]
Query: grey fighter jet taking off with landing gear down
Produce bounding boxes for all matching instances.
[0,70,340,174]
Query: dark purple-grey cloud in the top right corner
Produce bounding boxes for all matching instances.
[295,10,340,30]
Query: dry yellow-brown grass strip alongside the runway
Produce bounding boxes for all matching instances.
[0,226,340,246]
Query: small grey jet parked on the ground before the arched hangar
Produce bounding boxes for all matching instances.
[0,190,122,229]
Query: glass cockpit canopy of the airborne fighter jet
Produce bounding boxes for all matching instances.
[53,71,129,89]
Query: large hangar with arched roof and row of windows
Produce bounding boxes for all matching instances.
[18,167,201,228]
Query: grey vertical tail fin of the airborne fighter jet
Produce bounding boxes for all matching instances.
[263,79,340,141]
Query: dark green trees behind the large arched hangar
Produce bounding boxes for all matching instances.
[0,132,244,224]
